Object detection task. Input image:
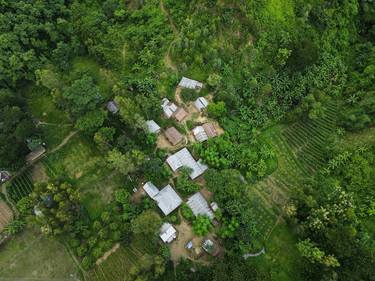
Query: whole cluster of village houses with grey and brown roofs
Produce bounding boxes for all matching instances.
[107,77,223,256]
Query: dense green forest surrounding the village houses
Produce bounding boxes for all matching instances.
[0,0,375,281]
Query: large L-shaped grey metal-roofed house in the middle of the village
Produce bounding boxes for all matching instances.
[166,147,208,180]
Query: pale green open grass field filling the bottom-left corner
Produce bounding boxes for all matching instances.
[0,226,80,281]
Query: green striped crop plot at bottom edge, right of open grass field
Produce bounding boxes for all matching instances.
[87,246,142,281]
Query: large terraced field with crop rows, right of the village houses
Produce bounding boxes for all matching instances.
[249,102,337,237]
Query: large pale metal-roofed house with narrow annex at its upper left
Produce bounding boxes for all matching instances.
[143,182,182,216]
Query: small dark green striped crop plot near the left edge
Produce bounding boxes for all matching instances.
[6,169,34,203]
